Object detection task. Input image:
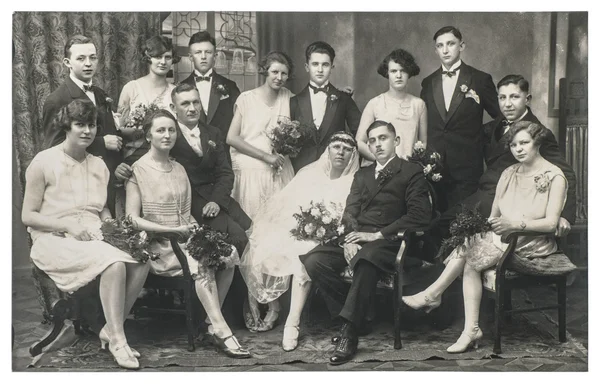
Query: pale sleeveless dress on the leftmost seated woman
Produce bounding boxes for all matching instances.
[25,145,137,293]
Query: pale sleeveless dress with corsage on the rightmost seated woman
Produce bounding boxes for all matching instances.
[446,161,576,275]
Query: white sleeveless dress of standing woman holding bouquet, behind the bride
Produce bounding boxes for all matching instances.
[231,88,294,218]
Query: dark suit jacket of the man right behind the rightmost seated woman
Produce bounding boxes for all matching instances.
[479,108,576,223]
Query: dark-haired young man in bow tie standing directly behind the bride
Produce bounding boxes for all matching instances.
[290,41,360,172]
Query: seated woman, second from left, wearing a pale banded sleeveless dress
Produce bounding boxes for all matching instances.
[125,109,250,358]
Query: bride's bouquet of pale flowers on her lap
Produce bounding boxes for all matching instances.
[290,201,345,244]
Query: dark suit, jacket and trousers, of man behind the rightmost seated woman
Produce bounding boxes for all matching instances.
[439,108,576,237]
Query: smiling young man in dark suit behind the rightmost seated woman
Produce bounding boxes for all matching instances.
[438,75,576,242]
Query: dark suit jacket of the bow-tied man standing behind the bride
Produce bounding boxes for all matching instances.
[290,84,360,172]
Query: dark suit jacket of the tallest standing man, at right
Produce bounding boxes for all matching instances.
[421,62,501,180]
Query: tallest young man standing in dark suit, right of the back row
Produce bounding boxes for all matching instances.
[421,26,500,212]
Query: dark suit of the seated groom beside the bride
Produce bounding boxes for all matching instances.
[300,157,431,326]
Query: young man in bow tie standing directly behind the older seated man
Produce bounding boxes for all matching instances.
[182,31,240,160]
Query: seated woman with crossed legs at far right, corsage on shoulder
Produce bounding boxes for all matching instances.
[402,121,575,353]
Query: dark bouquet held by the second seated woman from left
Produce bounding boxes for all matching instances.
[187,224,233,271]
